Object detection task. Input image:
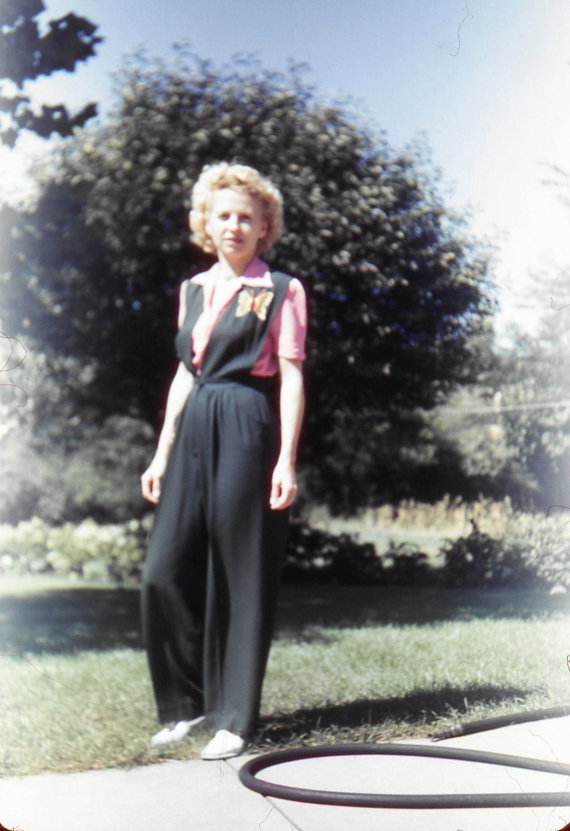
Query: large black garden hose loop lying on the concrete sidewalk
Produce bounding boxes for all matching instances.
[239,744,570,808]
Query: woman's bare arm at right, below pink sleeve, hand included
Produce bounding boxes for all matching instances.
[269,358,305,511]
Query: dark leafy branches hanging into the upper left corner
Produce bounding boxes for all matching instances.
[0,0,101,147]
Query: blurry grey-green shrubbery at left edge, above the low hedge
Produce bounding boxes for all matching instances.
[0,336,153,524]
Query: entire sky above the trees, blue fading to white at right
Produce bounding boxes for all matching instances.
[4,0,570,332]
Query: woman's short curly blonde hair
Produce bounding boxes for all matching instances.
[190,162,283,254]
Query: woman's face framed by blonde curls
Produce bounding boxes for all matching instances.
[206,188,267,266]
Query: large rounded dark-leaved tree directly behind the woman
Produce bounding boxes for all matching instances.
[5,56,492,509]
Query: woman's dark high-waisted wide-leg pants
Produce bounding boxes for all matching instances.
[142,382,288,737]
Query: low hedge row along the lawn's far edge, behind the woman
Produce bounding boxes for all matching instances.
[0,515,570,589]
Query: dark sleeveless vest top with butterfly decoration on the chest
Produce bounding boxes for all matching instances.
[176,271,291,383]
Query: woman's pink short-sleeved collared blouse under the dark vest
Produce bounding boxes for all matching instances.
[178,257,307,376]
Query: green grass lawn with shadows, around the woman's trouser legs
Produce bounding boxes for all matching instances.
[0,579,570,775]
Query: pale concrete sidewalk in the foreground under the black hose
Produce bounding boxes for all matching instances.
[0,717,570,831]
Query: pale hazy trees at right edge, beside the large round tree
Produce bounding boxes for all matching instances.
[429,270,570,510]
